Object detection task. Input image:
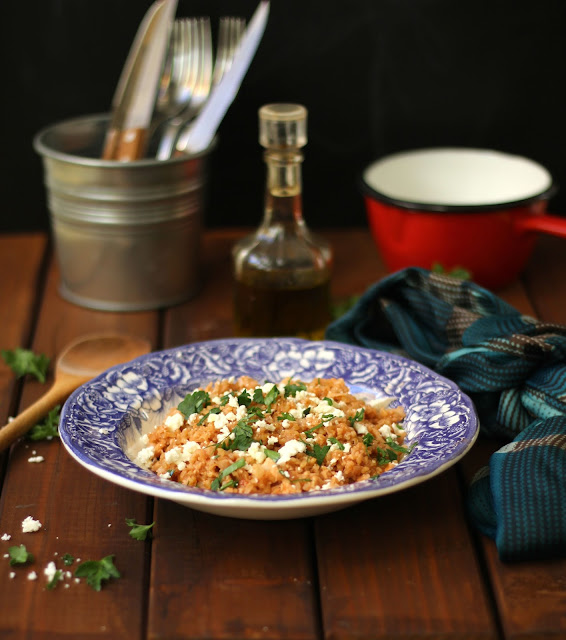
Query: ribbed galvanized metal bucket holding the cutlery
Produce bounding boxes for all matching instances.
[34,115,215,311]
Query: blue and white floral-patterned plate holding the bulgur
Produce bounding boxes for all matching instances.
[59,338,479,519]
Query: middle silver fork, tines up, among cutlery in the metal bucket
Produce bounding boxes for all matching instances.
[157,18,213,160]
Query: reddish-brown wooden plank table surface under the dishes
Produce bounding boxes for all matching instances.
[0,229,566,640]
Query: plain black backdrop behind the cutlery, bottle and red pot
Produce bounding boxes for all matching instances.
[0,0,566,230]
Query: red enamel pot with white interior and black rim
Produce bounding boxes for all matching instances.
[361,148,566,289]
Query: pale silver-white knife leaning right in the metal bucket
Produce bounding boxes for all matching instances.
[176,0,269,153]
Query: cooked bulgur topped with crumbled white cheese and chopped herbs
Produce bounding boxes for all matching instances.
[136,377,407,494]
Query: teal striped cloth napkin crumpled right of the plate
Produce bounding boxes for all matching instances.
[325,267,566,561]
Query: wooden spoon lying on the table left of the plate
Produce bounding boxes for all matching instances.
[0,333,151,451]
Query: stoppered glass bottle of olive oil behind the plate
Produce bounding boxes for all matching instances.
[233,104,332,339]
